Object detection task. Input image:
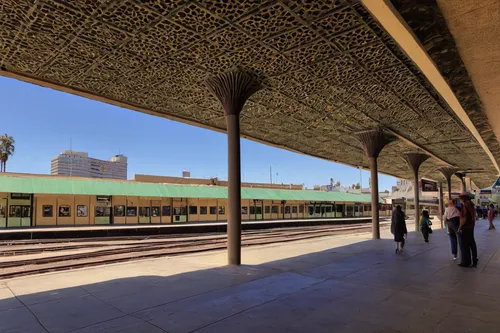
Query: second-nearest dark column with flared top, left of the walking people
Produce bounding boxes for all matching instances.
[354,128,396,239]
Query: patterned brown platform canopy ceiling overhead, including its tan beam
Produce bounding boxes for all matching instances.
[0,0,500,187]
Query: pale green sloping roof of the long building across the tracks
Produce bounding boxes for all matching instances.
[0,175,382,203]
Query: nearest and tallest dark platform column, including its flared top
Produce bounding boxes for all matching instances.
[205,69,261,265]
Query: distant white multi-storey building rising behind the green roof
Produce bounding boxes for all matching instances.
[50,150,127,179]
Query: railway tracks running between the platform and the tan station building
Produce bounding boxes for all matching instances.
[0,222,389,279]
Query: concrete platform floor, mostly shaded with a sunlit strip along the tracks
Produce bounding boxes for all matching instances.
[0,220,500,333]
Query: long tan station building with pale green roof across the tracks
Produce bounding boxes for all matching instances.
[0,174,390,228]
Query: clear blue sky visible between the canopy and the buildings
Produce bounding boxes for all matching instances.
[0,77,396,190]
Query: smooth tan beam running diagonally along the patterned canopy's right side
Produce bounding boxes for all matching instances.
[361,0,500,174]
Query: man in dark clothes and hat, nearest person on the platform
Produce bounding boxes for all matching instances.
[458,192,479,267]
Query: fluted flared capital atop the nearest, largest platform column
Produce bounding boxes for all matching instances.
[205,69,262,116]
